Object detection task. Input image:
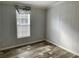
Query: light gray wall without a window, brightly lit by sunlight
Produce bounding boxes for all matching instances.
[46,2,79,55]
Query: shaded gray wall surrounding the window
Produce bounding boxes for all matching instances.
[0,4,45,50]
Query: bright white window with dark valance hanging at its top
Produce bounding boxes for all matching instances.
[16,9,30,38]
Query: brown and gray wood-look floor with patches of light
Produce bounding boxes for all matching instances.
[0,41,79,58]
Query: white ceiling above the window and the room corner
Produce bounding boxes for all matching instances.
[0,1,58,9]
